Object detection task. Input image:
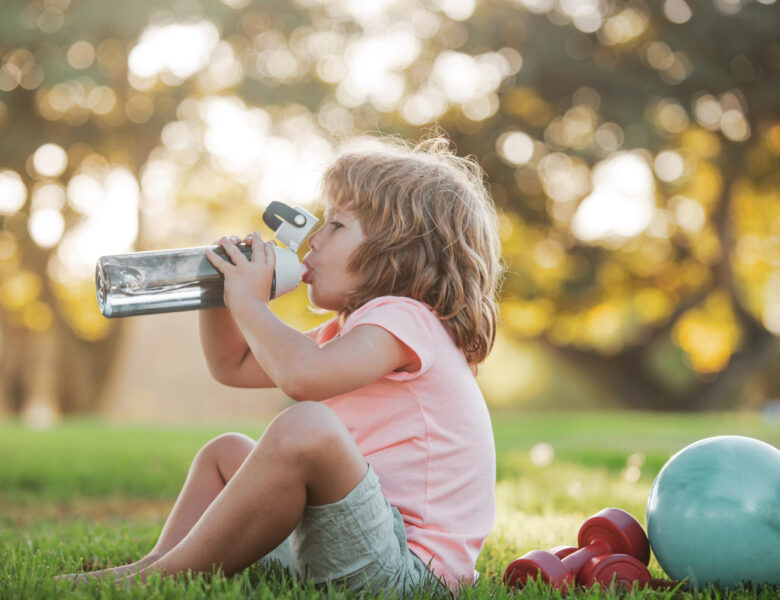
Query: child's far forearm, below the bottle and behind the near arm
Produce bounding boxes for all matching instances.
[199,308,276,388]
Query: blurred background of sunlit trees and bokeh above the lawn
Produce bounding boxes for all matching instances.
[0,0,780,427]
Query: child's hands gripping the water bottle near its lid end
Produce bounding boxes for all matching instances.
[206,231,276,309]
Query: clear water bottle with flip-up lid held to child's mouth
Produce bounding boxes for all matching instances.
[95,202,318,318]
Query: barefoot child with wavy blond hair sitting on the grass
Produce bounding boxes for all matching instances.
[65,138,502,594]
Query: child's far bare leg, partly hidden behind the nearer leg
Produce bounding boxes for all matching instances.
[66,433,255,579]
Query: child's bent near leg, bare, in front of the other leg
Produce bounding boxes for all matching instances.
[125,402,368,580]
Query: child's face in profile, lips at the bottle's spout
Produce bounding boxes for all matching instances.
[303,209,365,311]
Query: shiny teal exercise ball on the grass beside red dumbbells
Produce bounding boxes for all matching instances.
[647,435,780,587]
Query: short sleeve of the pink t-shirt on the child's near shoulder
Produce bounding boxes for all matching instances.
[341,296,436,381]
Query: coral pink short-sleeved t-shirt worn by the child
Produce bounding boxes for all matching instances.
[307,296,496,589]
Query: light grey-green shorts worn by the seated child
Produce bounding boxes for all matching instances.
[258,465,449,597]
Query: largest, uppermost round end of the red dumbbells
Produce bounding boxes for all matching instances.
[577,508,650,565]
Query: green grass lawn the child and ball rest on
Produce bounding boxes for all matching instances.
[0,413,780,600]
